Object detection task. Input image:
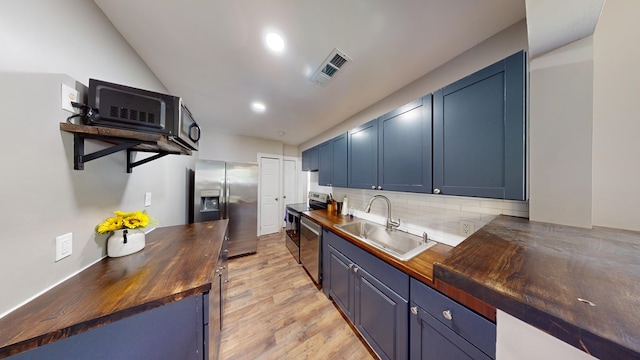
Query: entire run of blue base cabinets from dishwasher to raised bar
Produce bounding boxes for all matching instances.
[323,229,496,360]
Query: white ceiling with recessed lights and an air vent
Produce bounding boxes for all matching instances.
[94,0,525,145]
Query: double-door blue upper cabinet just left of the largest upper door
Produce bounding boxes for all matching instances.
[349,94,432,192]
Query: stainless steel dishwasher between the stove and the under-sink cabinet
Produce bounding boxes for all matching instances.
[300,216,322,288]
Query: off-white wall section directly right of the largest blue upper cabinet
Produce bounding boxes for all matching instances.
[529,37,593,228]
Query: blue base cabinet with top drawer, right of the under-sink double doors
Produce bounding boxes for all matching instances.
[409,279,496,360]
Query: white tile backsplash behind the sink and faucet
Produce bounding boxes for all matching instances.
[310,183,529,246]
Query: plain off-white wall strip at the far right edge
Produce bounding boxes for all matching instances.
[593,0,640,231]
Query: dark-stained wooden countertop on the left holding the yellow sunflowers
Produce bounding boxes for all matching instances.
[0,220,228,358]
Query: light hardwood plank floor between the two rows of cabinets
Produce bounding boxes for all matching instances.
[220,233,374,360]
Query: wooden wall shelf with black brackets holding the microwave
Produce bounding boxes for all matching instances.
[60,122,191,173]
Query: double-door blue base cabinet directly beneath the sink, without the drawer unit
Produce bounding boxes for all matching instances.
[323,230,409,359]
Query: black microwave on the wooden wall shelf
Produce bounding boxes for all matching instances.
[84,79,200,150]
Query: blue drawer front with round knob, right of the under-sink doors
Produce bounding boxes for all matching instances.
[410,278,496,357]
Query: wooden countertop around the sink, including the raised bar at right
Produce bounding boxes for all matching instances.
[304,210,640,359]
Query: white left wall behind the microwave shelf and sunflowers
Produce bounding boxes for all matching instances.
[0,0,193,316]
